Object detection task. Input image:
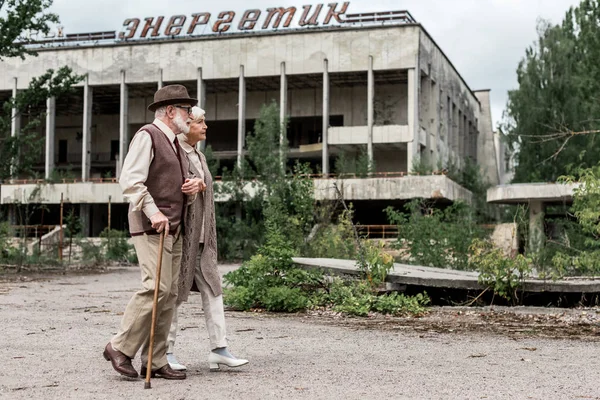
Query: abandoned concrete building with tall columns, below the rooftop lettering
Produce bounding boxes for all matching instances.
[0,9,502,235]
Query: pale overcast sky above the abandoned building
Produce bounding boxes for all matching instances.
[52,0,579,127]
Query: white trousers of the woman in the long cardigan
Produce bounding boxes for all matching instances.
[167,244,227,353]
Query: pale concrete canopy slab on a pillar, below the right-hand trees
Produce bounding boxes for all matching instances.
[487,183,579,204]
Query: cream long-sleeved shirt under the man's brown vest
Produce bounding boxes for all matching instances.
[119,119,190,218]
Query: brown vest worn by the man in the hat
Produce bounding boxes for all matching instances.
[128,124,189,236]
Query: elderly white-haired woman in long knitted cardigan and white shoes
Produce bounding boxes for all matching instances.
[167,107,248,371]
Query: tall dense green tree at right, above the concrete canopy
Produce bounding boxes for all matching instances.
[502,0,600,182]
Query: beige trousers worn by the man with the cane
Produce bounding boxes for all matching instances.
[111,231,183,369]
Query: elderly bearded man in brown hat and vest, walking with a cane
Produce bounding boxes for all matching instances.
[104,85,201,379]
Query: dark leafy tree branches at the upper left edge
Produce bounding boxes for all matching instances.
[0,0,83,180]
